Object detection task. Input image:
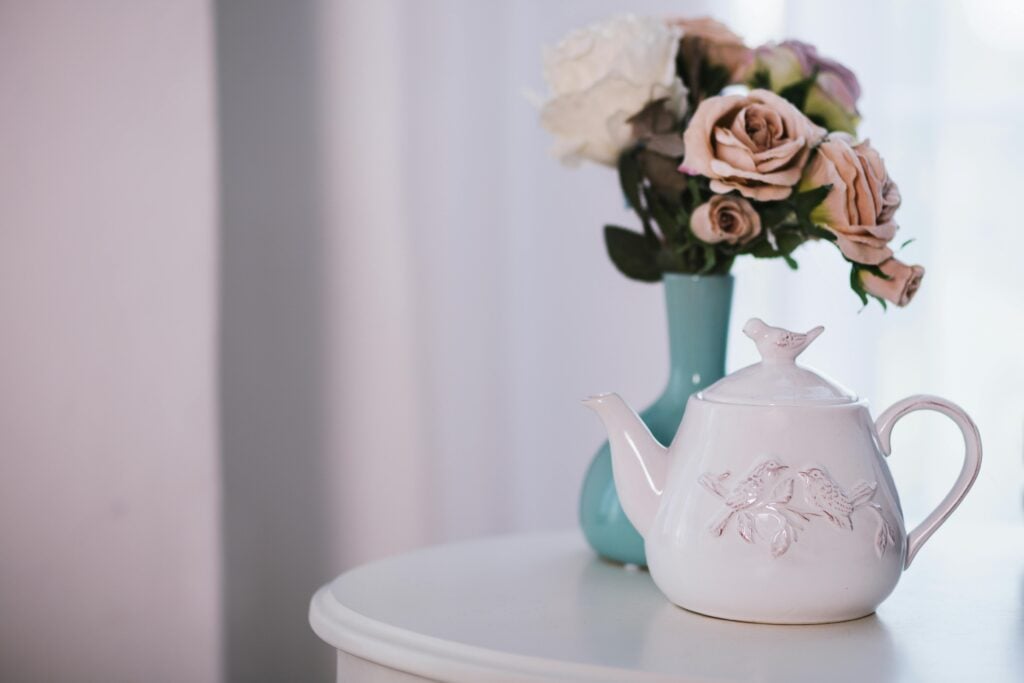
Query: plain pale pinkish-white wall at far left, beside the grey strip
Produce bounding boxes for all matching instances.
[0,0,220,683]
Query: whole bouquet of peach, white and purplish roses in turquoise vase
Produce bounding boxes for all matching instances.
[541,16,925,306]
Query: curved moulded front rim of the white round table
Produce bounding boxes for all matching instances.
[309,584,710,683]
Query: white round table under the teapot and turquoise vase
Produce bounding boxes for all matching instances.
[309,526,1024,683]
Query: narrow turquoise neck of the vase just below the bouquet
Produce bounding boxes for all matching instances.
[664,274,733,398]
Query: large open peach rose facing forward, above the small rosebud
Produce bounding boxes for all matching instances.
[679,90,825,202]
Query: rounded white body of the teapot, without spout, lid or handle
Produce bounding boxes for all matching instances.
[645,395,907,624]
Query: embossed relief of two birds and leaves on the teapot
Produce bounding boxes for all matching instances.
[699,458,896,557]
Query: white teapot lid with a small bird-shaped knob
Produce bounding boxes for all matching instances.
[697,317,857,405]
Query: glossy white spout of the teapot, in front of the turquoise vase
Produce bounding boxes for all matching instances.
[583,393,669,538]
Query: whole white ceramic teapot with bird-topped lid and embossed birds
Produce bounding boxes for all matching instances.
[585,318,981,624]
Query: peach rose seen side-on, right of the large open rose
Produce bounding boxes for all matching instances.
[800,133,900,265]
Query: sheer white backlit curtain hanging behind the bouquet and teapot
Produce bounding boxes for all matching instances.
[321,0,1024,562]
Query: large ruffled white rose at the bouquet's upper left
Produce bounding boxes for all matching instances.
[541,15,686,165]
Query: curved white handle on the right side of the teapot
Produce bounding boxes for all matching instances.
[874,394,981,569]
